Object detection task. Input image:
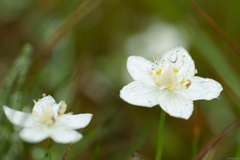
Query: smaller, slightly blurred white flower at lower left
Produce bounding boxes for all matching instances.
[3,95,92,143]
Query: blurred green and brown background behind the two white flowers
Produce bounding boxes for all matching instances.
[0,0,240,160]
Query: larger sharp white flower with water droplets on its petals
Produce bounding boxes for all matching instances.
[120,47,223,119]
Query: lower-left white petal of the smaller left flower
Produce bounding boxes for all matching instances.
[19,125,51,143]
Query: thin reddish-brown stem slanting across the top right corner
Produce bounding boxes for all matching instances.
[188,0,240,55]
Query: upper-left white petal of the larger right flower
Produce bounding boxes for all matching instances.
[127,56,152,82]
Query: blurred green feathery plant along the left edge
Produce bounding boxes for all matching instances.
[0,44,32,159]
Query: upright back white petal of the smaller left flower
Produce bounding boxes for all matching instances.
[33,95,56,115]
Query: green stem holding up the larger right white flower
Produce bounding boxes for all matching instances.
[156,110,166,160]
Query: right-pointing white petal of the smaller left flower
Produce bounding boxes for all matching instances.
[57,113,92,129]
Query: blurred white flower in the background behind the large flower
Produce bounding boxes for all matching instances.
[125,20,188,57]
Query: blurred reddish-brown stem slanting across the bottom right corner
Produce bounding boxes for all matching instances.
[195,119,240,160]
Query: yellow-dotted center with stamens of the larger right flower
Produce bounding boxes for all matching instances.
[148,51,194,92]
